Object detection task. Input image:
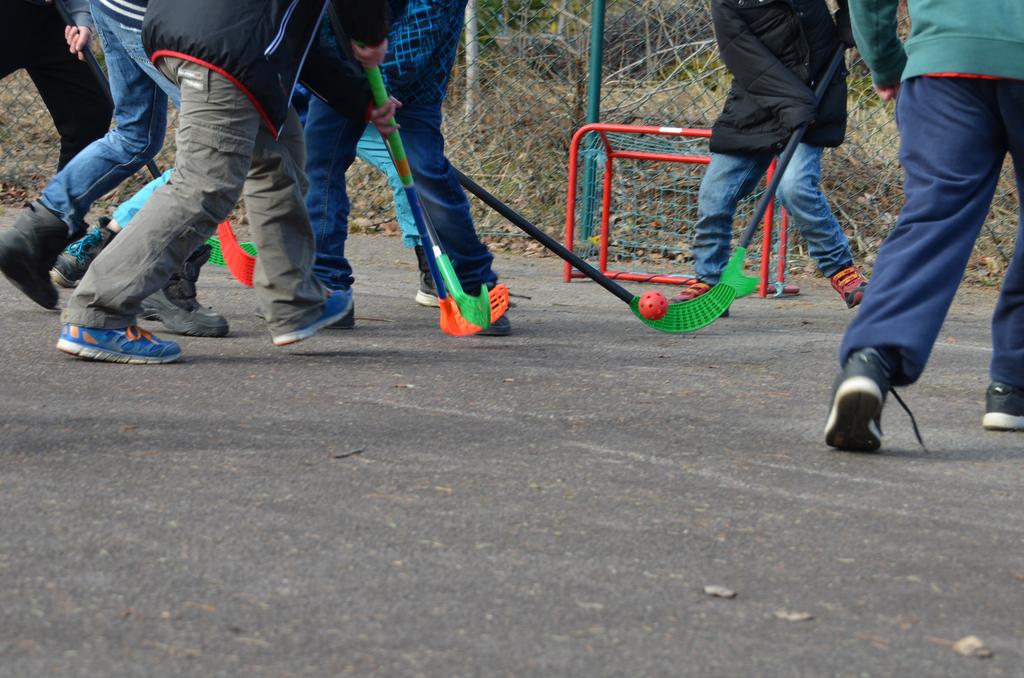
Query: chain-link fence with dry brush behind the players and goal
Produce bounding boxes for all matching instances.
[0,0,1018,281]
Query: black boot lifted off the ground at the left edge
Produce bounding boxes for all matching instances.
[0,201,68,308]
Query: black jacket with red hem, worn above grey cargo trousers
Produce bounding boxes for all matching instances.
[142,0,390,136]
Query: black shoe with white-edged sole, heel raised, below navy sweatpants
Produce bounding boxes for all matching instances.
[825,377,882,452]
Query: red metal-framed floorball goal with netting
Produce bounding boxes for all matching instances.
[564,123,800,297]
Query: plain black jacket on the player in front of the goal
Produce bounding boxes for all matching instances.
[711,0,846,154]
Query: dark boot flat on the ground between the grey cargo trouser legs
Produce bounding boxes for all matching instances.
[142,245,228,337]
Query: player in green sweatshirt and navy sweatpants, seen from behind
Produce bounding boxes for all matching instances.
[825,0,1024,451]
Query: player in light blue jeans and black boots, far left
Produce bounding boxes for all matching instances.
[0,0,228,337]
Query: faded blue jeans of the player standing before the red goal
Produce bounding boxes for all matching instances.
[693,143,853,285]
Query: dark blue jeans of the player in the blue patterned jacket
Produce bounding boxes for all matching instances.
[305,98,498,294]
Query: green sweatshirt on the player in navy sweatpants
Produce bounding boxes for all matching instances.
[849,0,1024,85]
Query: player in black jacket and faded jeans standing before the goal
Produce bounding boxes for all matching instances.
[675,0,867,308]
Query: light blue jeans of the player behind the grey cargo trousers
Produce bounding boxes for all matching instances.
[41,0,180,236]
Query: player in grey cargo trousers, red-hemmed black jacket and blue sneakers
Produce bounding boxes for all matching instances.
[48,0,393,364]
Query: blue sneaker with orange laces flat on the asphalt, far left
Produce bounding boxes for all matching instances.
[57,323,181,365]
